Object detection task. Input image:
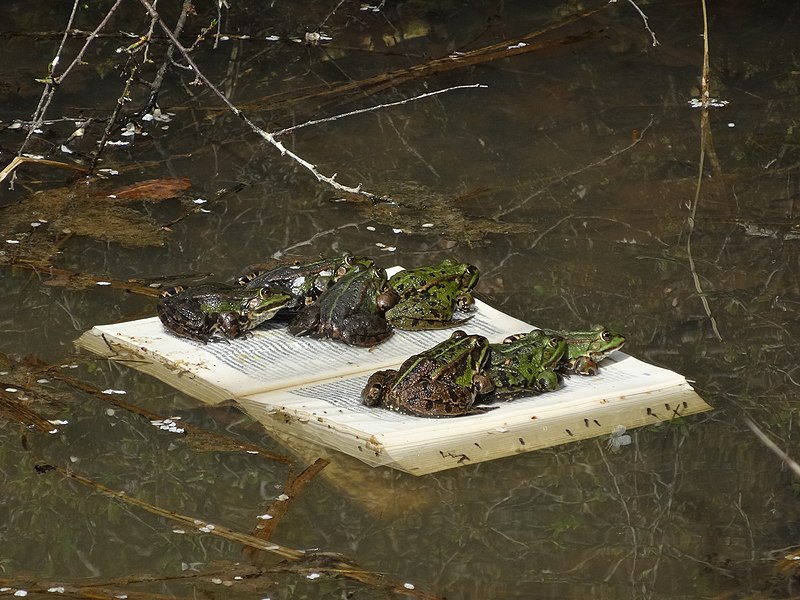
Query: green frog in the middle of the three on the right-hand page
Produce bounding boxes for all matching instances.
[487,329,567,397]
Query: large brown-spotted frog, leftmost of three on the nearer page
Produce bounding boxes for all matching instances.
[361,330,493,417]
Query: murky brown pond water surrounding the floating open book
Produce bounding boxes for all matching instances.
[0,0,800,599]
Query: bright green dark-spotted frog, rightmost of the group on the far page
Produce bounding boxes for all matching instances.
[386,258,480,330]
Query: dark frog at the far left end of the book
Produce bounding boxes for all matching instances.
[156,283,292,343]
